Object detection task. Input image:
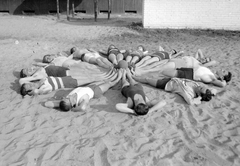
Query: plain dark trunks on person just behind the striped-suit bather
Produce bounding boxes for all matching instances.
[45,65,69,77]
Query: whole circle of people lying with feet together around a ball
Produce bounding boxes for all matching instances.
[19,45,232,115]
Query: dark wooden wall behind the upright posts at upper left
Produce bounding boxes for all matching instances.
[0,0,142,14]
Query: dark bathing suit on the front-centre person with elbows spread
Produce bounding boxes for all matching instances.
[121,84,146,108]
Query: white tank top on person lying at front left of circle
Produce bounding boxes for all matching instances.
[67,87,94,107]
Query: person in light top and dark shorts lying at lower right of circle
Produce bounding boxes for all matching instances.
[133,76,217,105]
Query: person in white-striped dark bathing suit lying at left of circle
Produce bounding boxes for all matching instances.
[20,68,118,96]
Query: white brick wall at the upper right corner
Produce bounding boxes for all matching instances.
[143,0,240,30]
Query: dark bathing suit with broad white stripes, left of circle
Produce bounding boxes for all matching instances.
[46,76,78,91]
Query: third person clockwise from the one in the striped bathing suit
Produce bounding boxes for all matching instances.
[72,47,113,69]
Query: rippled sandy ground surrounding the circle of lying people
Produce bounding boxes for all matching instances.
[0,15,240,166]
